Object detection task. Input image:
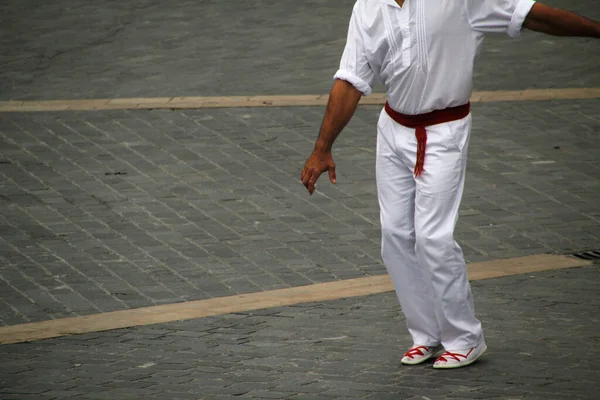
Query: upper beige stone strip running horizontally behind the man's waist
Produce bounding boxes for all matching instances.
[0,88,600,112]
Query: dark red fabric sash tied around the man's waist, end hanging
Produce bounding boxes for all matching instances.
[385,102,471,176]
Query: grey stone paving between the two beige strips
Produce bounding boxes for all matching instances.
[0,100,600,325]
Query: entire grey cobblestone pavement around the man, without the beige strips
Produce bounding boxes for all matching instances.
[0,0,600,400]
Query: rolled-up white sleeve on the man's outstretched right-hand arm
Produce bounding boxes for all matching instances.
[466,0,535,37]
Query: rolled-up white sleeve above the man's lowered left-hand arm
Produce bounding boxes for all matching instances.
[333,7,374,96]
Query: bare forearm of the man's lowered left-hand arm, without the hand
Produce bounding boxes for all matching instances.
[315,80,362,151]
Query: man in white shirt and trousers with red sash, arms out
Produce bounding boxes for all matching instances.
[301,0,600,368]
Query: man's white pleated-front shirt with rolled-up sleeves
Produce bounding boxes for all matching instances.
[334,0,534,115]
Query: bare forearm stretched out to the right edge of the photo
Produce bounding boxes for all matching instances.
[524,3,600,38]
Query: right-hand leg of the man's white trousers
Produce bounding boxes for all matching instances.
[409,116,483,349]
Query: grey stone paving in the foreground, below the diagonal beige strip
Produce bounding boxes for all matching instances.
[0,265,600,400]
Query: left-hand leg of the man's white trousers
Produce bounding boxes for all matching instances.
[376,112,440,346]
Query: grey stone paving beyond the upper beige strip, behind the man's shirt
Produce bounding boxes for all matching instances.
[0,0,600,100]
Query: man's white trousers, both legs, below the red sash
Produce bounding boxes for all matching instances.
[376,110,483,350]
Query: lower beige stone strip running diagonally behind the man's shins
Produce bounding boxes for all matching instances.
[0,254,592,344]
